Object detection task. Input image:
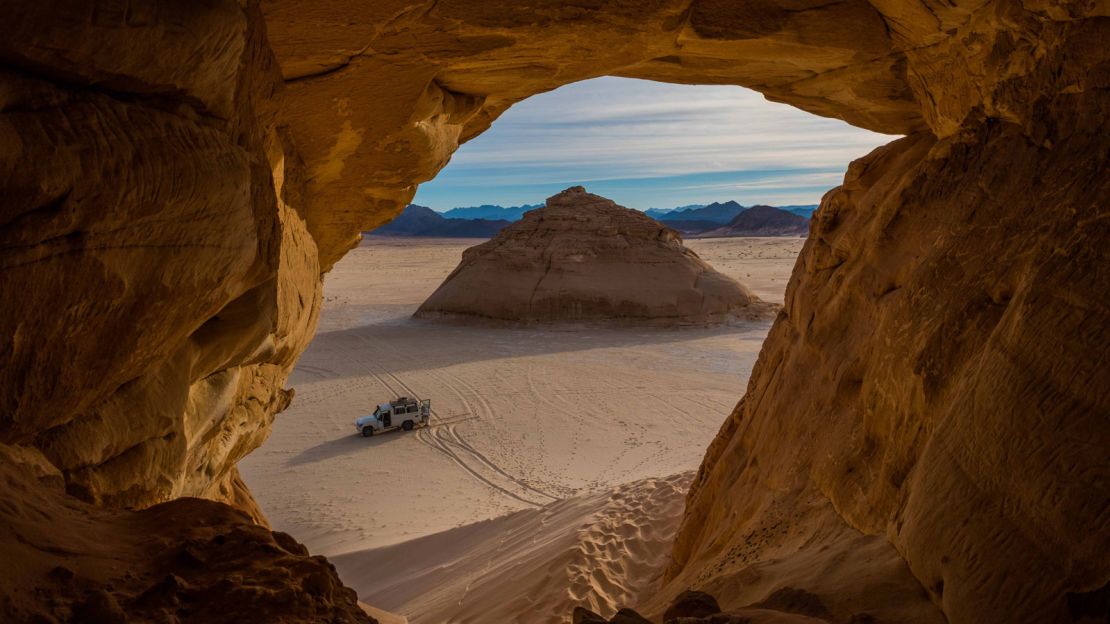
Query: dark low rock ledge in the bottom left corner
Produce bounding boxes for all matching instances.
[0,445,375,624]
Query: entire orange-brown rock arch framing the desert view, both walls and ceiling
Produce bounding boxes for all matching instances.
[0,0,1110,622]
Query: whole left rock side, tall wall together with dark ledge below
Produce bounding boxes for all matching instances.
[0,0,352,622]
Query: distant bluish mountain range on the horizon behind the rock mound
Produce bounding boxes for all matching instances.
[373,201,817,238]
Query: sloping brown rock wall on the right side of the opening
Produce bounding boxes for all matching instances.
[670,110,1110,622]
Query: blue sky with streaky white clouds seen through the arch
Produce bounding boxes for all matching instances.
[413,78,894,211]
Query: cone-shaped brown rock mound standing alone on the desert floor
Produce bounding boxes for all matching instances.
[416,187,775,325]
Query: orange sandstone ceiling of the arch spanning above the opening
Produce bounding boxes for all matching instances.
[263,0,927,266]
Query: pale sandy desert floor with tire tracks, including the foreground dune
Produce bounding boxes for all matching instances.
[240,236,804,624]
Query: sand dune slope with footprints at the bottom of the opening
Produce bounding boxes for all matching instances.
[332,472,693,624]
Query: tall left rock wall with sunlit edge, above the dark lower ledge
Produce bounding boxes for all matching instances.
[0,1,320,515]
